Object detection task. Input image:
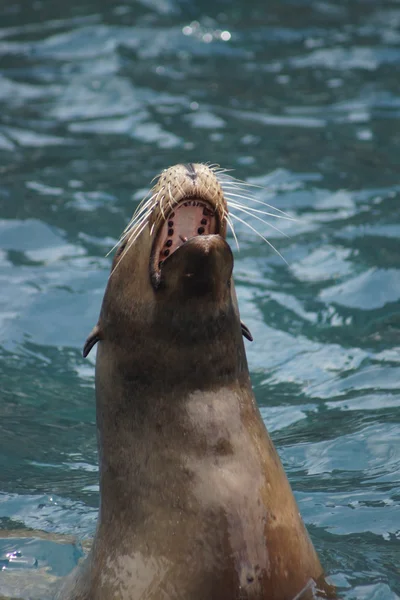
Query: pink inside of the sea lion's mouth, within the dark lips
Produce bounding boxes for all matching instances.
[158,200,217,265]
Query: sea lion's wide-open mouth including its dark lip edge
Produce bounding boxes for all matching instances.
[152,198,220,275]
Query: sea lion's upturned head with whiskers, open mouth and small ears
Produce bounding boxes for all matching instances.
[84,163,250,356]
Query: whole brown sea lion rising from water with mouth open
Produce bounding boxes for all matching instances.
[60,164,332,600]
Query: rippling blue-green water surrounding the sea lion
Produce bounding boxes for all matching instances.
[0,0,400,600]
